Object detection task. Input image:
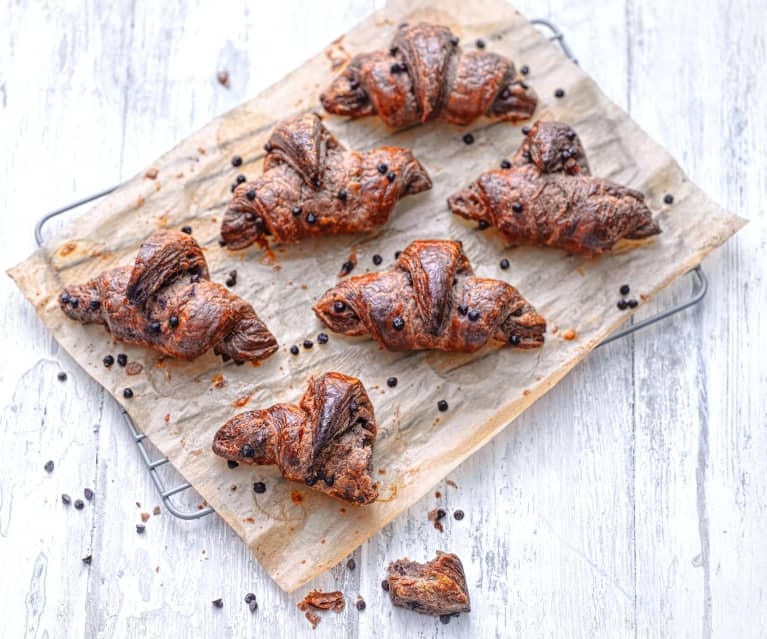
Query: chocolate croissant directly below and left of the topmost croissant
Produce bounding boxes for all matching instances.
[221,114,431,249]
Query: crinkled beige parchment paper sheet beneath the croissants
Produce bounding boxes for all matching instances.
[10,0,744,590]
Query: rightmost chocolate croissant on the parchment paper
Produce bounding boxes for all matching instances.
[447,122,661,256]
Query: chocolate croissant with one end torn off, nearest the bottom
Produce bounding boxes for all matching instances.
[213,373,378,504]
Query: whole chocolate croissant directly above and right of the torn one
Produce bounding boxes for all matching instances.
[314,240,546,353]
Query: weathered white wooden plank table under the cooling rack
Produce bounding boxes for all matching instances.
[0,0,767,638]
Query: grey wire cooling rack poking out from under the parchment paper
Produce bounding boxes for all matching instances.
[35,19,708,520]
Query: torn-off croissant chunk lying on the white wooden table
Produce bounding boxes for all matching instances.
[386,550,471,616]
